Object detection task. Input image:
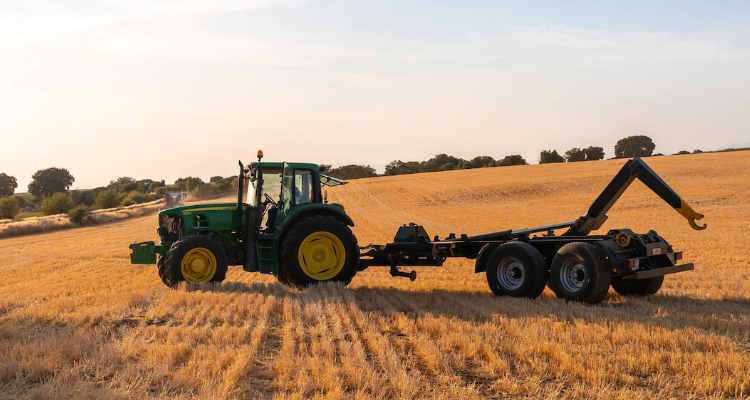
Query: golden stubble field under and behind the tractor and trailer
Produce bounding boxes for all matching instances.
[0,152,750,399]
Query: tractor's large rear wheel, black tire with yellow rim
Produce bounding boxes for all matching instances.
[279,215,359,287]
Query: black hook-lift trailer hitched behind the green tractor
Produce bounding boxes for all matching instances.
[359,158,706,304]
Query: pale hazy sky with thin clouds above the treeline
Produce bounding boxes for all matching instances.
[0,0,750,192]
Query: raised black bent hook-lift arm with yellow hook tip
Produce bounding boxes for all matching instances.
[563,157,706,236]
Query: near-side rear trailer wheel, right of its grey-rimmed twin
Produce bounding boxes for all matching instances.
[550,242,611,304]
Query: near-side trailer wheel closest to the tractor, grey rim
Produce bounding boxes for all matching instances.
[485,242,547,299]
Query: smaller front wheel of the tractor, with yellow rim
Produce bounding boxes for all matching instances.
[159,235,228,289]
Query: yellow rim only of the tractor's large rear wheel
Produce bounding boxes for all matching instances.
[298,231,346,281]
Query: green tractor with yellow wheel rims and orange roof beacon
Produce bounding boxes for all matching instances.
[130,151,359,288]
